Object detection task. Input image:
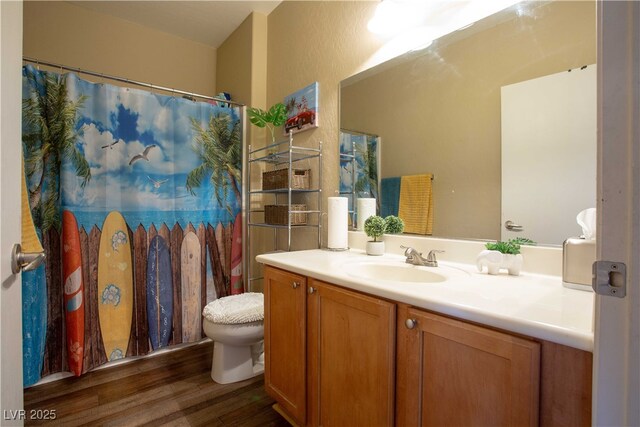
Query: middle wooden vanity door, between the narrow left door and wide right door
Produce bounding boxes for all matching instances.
[307,280,395,427]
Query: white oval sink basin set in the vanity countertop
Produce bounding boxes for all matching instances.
[344,262,447,283]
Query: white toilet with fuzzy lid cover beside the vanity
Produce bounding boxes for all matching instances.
[202,292,264,384]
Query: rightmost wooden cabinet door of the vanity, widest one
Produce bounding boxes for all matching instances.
[396,306,540,426]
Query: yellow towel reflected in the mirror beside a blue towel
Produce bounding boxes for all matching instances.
[398,173,433,234]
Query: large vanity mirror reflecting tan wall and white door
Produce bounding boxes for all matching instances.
[340,1,596,245]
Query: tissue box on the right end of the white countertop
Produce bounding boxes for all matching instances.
[562,237,596,291]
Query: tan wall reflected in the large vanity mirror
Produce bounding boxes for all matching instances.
[340,1,596,244]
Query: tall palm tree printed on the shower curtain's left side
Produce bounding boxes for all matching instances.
[22,68,91,232]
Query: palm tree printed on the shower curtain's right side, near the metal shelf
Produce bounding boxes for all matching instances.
[186,113,242,214]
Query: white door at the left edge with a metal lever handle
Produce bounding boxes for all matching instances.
[0,1,24,426]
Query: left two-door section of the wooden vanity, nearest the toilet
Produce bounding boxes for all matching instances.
[264,267,396,427]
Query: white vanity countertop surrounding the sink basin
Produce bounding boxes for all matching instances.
[256,249,594,351]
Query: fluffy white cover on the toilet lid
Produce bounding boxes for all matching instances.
[202,292,264,325]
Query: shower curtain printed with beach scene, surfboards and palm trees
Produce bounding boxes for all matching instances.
[22,66,244,386]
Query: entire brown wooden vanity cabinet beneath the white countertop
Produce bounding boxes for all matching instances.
[264,266,592,427]
